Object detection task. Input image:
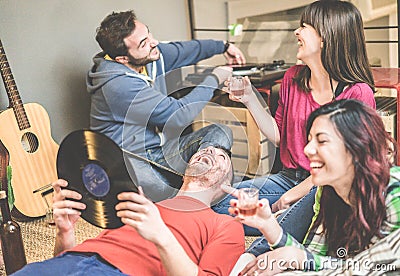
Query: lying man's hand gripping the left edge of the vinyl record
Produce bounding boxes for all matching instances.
[52,179,86,232]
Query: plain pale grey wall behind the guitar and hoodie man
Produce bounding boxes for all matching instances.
[0,0,190,143]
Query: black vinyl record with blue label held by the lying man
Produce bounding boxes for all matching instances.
[57,130,137,228]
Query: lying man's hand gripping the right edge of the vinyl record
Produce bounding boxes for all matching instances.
[115,187,169,244]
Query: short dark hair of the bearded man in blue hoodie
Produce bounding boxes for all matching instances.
[96,10,136,58]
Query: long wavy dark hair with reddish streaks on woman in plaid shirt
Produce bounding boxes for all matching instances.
[307,100,393,256]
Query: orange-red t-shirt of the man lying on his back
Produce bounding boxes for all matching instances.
[69,196,244,276]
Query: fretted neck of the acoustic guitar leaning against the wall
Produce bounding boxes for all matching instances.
[0,40,30,130]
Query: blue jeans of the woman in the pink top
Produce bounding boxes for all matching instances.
[212,169,308,236]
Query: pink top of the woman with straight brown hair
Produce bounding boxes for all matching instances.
[275,65,376,171]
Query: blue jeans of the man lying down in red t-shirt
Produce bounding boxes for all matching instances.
[12,252,127,276]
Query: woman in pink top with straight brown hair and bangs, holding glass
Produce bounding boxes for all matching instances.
[213,0,376,237]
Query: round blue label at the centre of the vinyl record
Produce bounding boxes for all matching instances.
[82,163,110,197]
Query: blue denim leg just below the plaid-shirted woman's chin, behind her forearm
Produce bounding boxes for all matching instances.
[247,187,317,257]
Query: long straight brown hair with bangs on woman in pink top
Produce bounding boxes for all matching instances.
[294,0,375,92]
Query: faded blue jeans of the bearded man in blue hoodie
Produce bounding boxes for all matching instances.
[125,124,233,202]
